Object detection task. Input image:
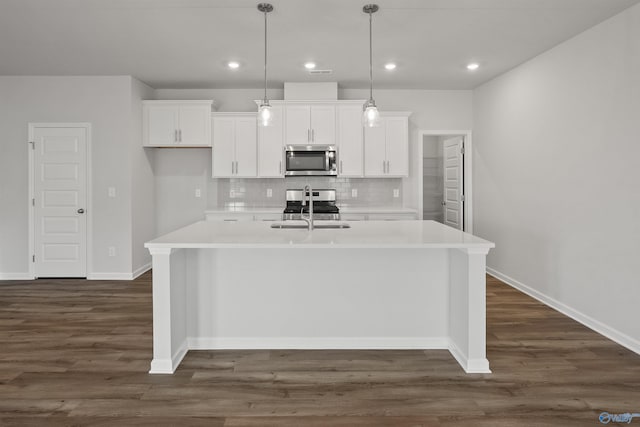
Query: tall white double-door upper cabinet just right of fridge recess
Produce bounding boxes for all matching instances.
[211,113,258,178]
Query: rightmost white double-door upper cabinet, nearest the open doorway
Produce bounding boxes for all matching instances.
[364,113,410,177]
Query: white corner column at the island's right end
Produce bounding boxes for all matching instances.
[449,248,491,373]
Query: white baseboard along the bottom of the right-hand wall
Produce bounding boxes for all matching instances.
[487,267,640,354]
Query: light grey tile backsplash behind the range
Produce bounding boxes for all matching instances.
[212,176,402,209]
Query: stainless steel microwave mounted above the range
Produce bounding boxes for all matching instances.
[284,145,338,176]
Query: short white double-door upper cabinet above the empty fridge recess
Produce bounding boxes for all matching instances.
[142,100,213,147]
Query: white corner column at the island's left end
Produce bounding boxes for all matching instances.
[144,247,188,374]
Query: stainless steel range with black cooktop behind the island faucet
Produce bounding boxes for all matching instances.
[282,189,340,220]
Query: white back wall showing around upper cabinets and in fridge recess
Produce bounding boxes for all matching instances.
[155,89,473,234]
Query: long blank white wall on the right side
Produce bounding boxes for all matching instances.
[473,6,640,352]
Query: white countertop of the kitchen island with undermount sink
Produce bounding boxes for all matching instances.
[145,221,495,251]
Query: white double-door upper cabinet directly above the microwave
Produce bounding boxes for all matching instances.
[285,103,336,145]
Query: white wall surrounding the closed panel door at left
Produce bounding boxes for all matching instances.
[0,76,151,278]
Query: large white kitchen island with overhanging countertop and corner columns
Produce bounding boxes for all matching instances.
[145,221,494,374]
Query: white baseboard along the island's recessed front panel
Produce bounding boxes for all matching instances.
[189,337,449,350]
